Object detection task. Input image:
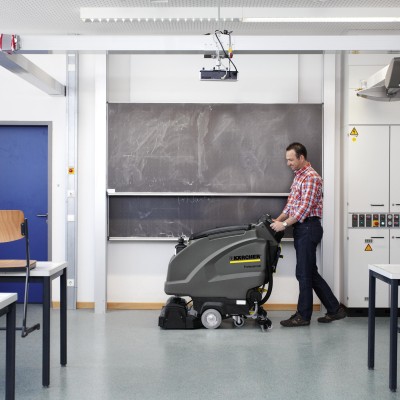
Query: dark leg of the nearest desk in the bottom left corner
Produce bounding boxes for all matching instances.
[6,303,16,400]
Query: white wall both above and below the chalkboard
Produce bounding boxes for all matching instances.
[104,55,323,304]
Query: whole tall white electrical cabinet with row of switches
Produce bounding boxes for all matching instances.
[343,126,400,308]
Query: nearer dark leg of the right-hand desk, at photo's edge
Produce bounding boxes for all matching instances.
[389,279,399,392]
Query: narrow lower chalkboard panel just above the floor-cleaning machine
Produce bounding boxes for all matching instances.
[108,196,291,237]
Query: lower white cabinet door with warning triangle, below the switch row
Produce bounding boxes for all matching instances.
[344,228,389,308]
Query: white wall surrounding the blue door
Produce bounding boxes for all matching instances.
[0,54,67,298]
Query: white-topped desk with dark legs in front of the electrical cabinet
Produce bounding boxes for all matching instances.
[368,264,400,392]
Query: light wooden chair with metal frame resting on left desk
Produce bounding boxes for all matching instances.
[0,210,40,337]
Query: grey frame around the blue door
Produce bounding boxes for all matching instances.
[0,121,53,260]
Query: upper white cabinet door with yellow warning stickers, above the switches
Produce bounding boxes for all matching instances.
[347,126,389,212]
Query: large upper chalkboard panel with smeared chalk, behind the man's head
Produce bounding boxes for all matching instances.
[108,103,322,193]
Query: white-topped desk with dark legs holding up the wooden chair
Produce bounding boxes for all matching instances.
[0,261,67,387]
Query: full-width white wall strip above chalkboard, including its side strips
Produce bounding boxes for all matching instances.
[108,54,323,104]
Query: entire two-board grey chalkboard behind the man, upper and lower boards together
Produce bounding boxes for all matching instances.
[108,103,322,237]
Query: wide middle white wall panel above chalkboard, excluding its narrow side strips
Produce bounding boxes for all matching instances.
[130,54,298,103]
